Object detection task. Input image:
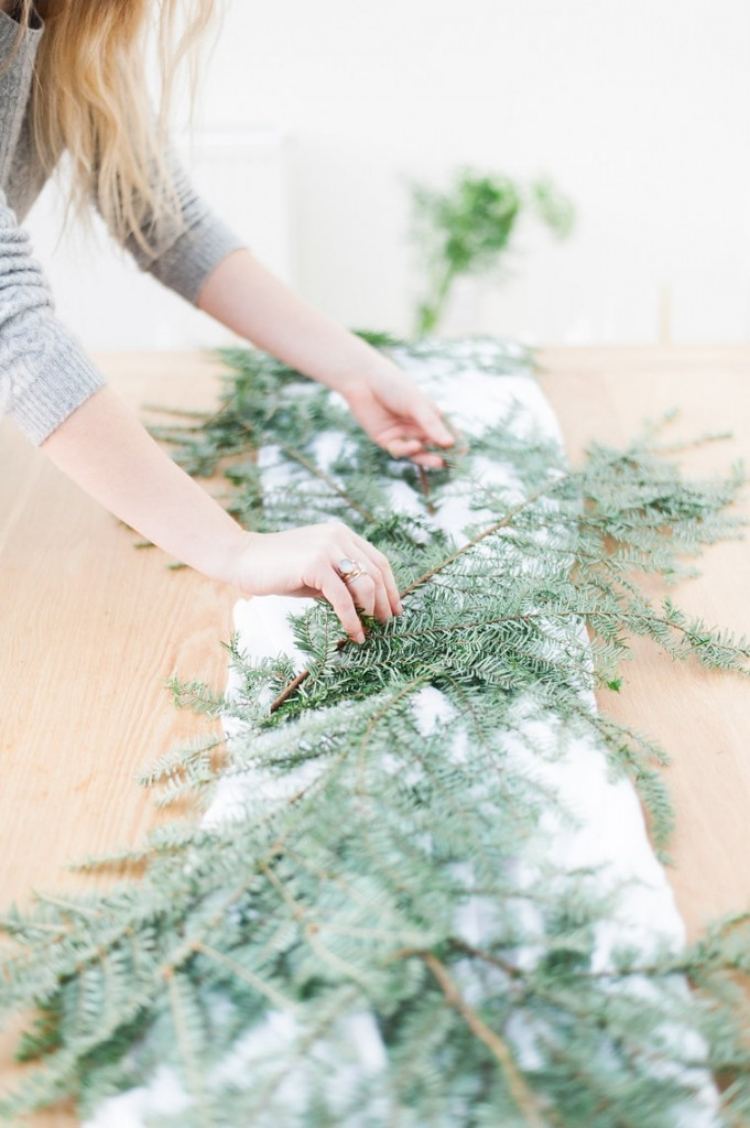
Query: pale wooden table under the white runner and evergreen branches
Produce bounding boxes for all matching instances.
[0,347,750,1128]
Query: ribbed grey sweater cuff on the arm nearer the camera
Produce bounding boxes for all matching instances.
[8,355,105,447]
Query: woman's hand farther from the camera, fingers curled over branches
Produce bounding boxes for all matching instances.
[338,361,456,469]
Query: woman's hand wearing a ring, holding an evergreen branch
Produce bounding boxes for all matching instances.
[233,521,402,643]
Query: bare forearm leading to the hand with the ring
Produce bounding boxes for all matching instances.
[42,387,247,580]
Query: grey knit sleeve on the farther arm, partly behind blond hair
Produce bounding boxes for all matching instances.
[104,138,246,305]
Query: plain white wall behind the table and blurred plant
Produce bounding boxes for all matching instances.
[26,0,750,343]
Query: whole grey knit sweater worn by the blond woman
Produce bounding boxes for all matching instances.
[0,5,244,444]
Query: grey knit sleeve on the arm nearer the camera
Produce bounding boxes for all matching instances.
[0,190,105,446]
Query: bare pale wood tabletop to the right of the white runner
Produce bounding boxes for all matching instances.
[539,347,750,936]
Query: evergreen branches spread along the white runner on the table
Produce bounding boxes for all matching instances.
[0,342,750,1128]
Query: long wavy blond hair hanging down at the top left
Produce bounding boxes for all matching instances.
[2,0,219,253]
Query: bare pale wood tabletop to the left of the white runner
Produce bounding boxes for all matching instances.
[0,353,233,1128]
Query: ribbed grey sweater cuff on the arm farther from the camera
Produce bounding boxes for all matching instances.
[140,213,247,306]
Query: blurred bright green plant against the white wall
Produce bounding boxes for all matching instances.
[412,169,575,336]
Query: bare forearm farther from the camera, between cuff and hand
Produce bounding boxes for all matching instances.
[196,249,392,390]
